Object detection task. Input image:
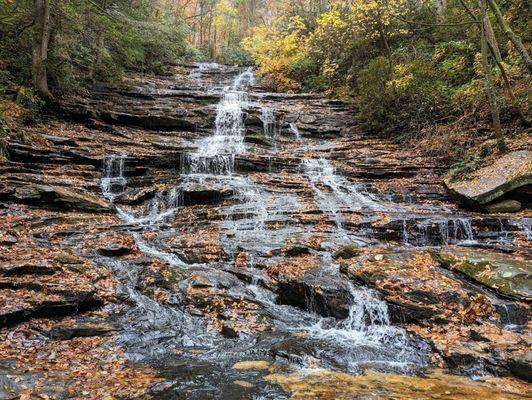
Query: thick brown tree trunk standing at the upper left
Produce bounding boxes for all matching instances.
[32,0,52,100]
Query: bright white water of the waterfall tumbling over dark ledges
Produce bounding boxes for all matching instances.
[97,69,430,376]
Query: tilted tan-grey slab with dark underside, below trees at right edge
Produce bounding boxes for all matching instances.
[445,150,532,206]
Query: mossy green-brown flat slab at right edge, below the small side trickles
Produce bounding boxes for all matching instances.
[434,247,532,301]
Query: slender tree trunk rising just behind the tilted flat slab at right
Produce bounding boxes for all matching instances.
[478,0,506,152]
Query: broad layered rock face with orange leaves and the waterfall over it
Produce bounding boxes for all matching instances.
[0,65,531,399]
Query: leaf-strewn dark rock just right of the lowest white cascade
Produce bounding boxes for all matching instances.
[340,251,493,323]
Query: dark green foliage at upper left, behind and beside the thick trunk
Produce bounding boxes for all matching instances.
[0,0,199,92]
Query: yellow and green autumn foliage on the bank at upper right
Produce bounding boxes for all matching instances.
[244,0,530,150]
